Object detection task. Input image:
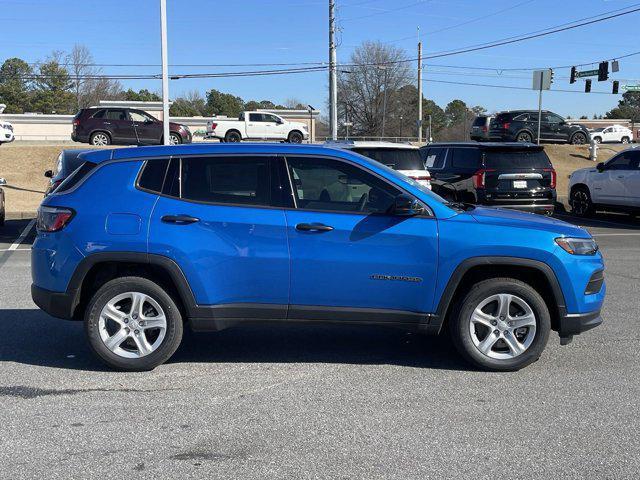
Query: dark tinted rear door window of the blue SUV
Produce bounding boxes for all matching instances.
[174,157,271,206]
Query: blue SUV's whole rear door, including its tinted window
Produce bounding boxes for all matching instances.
[149,157,289,310]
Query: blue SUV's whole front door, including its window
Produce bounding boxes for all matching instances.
[286,157,438,321]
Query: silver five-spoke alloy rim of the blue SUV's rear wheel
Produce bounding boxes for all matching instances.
[98,292,167,358]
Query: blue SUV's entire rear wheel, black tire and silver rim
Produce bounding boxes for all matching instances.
[85,277,183,371]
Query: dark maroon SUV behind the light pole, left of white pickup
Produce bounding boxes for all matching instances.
[71,107,191,145]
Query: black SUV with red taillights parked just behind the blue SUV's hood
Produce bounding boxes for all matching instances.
[420,142,556,215]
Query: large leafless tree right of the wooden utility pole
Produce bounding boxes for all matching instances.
[338,42,418,136]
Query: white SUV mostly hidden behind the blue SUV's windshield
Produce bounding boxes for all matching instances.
[326,140,431,189]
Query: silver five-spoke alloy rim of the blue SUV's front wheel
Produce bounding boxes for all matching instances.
[469,293,537,360]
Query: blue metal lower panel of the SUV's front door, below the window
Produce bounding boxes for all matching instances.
[286,210,438,313]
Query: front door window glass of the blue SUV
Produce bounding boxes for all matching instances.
[287,157,400,213]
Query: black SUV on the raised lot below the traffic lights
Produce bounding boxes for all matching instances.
[489,110,590,145]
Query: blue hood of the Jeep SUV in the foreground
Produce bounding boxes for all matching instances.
[467,207,591,238]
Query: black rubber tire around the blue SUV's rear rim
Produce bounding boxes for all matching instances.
[84,277,183,372]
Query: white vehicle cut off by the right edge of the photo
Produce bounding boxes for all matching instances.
[569,148,640,216]
